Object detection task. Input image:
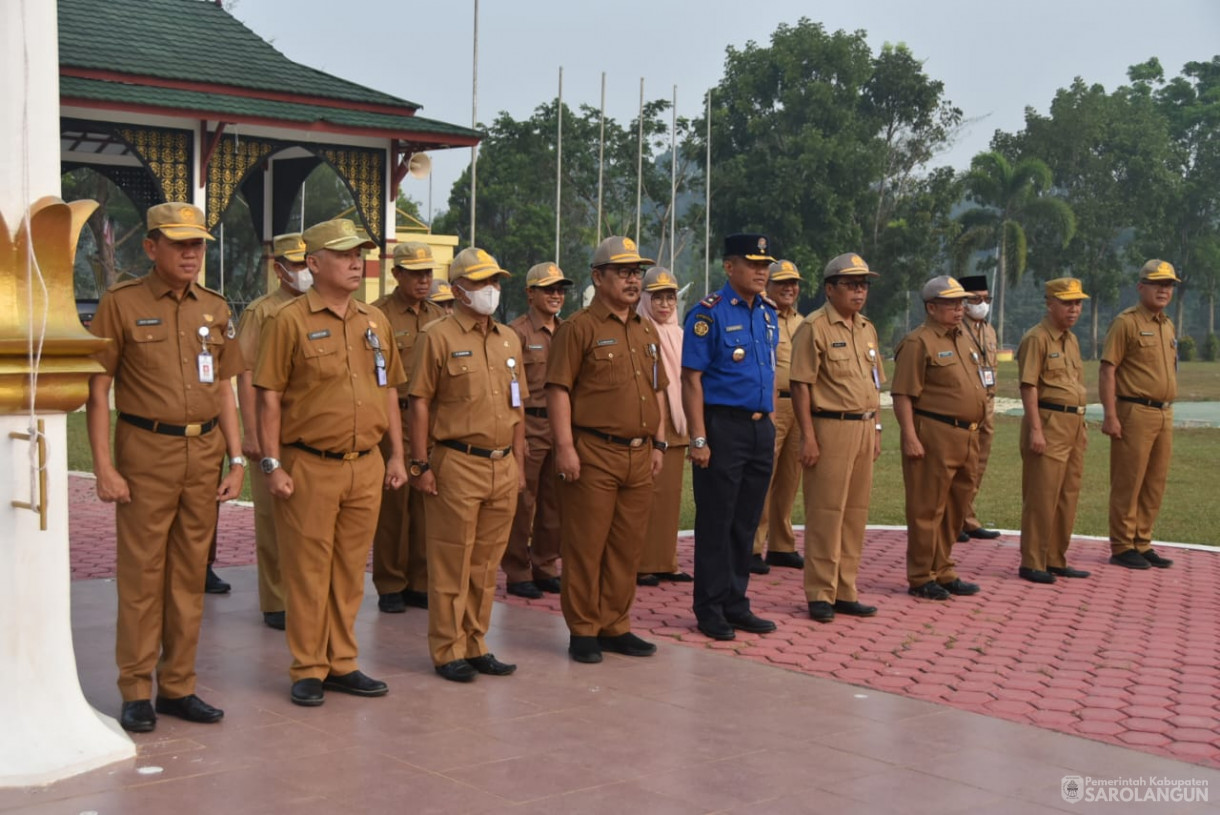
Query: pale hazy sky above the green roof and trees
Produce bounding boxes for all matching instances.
[233,0,1220,218]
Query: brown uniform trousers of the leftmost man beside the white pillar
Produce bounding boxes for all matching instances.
[115,421,224,702]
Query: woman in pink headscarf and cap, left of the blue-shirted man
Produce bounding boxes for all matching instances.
[636,266,694,586]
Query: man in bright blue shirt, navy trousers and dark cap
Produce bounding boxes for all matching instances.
[682,234,780,639]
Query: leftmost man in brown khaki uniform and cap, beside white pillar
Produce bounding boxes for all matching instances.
[87,203,245,733]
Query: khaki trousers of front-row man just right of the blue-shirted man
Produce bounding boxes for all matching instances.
[804,416,877,603]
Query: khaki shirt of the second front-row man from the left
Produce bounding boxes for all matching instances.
[254,289,405,453]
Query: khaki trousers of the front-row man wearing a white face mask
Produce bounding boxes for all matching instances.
[423,445,517,665]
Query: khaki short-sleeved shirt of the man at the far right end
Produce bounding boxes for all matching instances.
[1102,304,1177,401]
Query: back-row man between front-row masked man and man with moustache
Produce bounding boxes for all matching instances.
[500,264,572,600]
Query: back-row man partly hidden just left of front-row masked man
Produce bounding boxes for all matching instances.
[373,240,445,614]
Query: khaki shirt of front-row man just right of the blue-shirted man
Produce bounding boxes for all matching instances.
[792,303,886,414]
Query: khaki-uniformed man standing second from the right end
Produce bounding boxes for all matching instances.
[1016,277,1088,583]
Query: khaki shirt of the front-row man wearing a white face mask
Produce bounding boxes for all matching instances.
[407,311,529,450]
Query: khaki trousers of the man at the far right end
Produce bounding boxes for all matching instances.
[1110,401,1174,555]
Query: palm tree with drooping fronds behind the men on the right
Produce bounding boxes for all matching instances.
[954,153,1076,346]
